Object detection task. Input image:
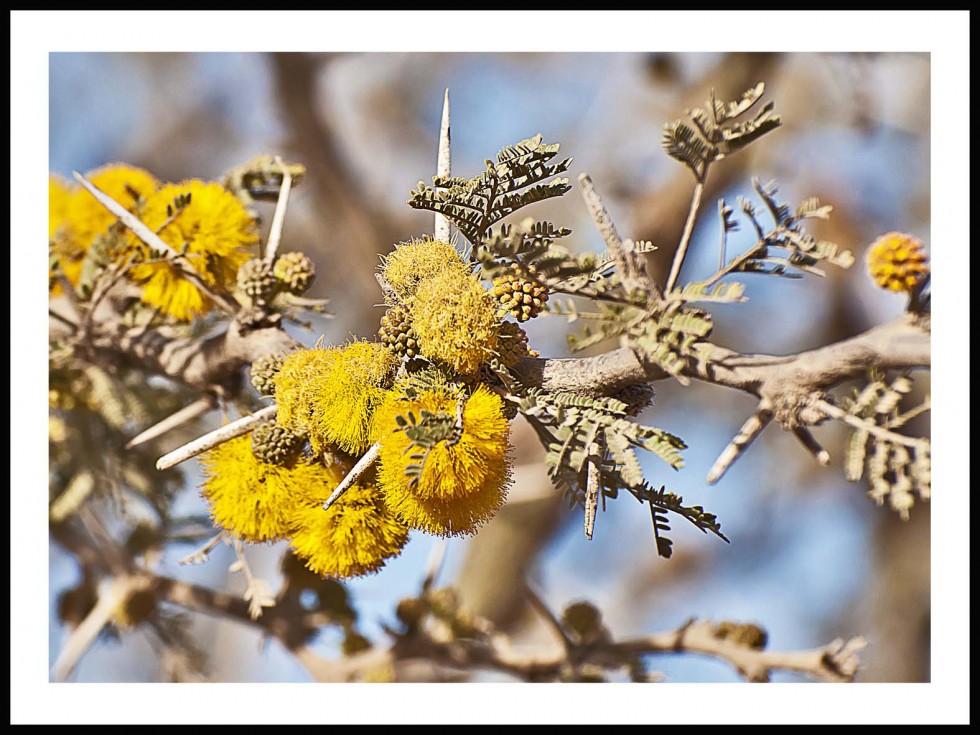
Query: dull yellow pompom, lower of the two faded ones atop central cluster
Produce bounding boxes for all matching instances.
[409,269,499,375]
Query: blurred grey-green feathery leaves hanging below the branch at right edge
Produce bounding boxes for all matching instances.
[844,373,932,520]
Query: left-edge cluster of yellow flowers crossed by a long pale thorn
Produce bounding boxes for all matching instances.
[48,164,259,321]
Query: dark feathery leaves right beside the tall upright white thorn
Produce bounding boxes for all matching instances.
[408,134,572,246]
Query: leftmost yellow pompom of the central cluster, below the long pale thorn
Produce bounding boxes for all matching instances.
[201,436,343,543]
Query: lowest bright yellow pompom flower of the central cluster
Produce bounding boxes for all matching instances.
[291,480,408,579]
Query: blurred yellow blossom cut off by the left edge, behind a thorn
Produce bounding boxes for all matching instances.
[48,163,160,292]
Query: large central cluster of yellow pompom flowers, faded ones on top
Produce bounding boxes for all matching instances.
[193,239,526,577]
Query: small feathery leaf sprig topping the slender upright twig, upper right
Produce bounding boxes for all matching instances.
[661,82,782,179]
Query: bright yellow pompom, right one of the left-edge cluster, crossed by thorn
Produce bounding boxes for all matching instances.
[130,179,259,321]
